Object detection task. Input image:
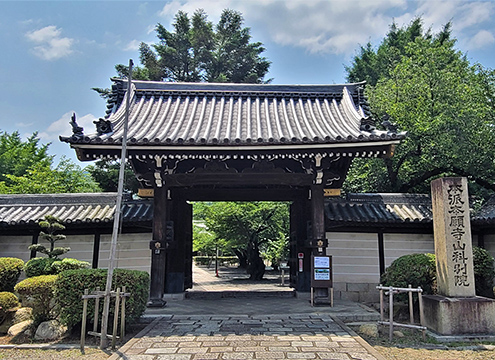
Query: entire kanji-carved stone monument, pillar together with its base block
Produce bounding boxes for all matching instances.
[423,178,495,335]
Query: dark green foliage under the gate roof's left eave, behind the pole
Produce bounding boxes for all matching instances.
[86,160,139,194]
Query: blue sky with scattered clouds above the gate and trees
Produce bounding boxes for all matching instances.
[0,0,495,166]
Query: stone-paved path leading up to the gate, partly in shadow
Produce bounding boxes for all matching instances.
[110,314,383,360]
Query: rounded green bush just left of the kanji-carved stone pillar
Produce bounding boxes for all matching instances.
[381,254,436,300]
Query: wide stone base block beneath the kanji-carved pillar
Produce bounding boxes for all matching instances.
[423,295,495,335]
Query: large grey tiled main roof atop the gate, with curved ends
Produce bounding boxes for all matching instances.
[61,79,405,147]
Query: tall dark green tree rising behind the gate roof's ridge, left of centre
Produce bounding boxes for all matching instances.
[136,9,270,83]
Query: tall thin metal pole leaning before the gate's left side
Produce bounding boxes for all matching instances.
[100,59,133,349]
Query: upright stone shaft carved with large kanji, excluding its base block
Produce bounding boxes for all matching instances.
[431,178,476,297]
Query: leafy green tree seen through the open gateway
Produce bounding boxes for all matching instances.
[199,202,289,280]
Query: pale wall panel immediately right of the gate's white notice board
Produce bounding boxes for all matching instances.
[326,232,380,284]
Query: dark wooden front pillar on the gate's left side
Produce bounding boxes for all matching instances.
[148,186,168,307]
